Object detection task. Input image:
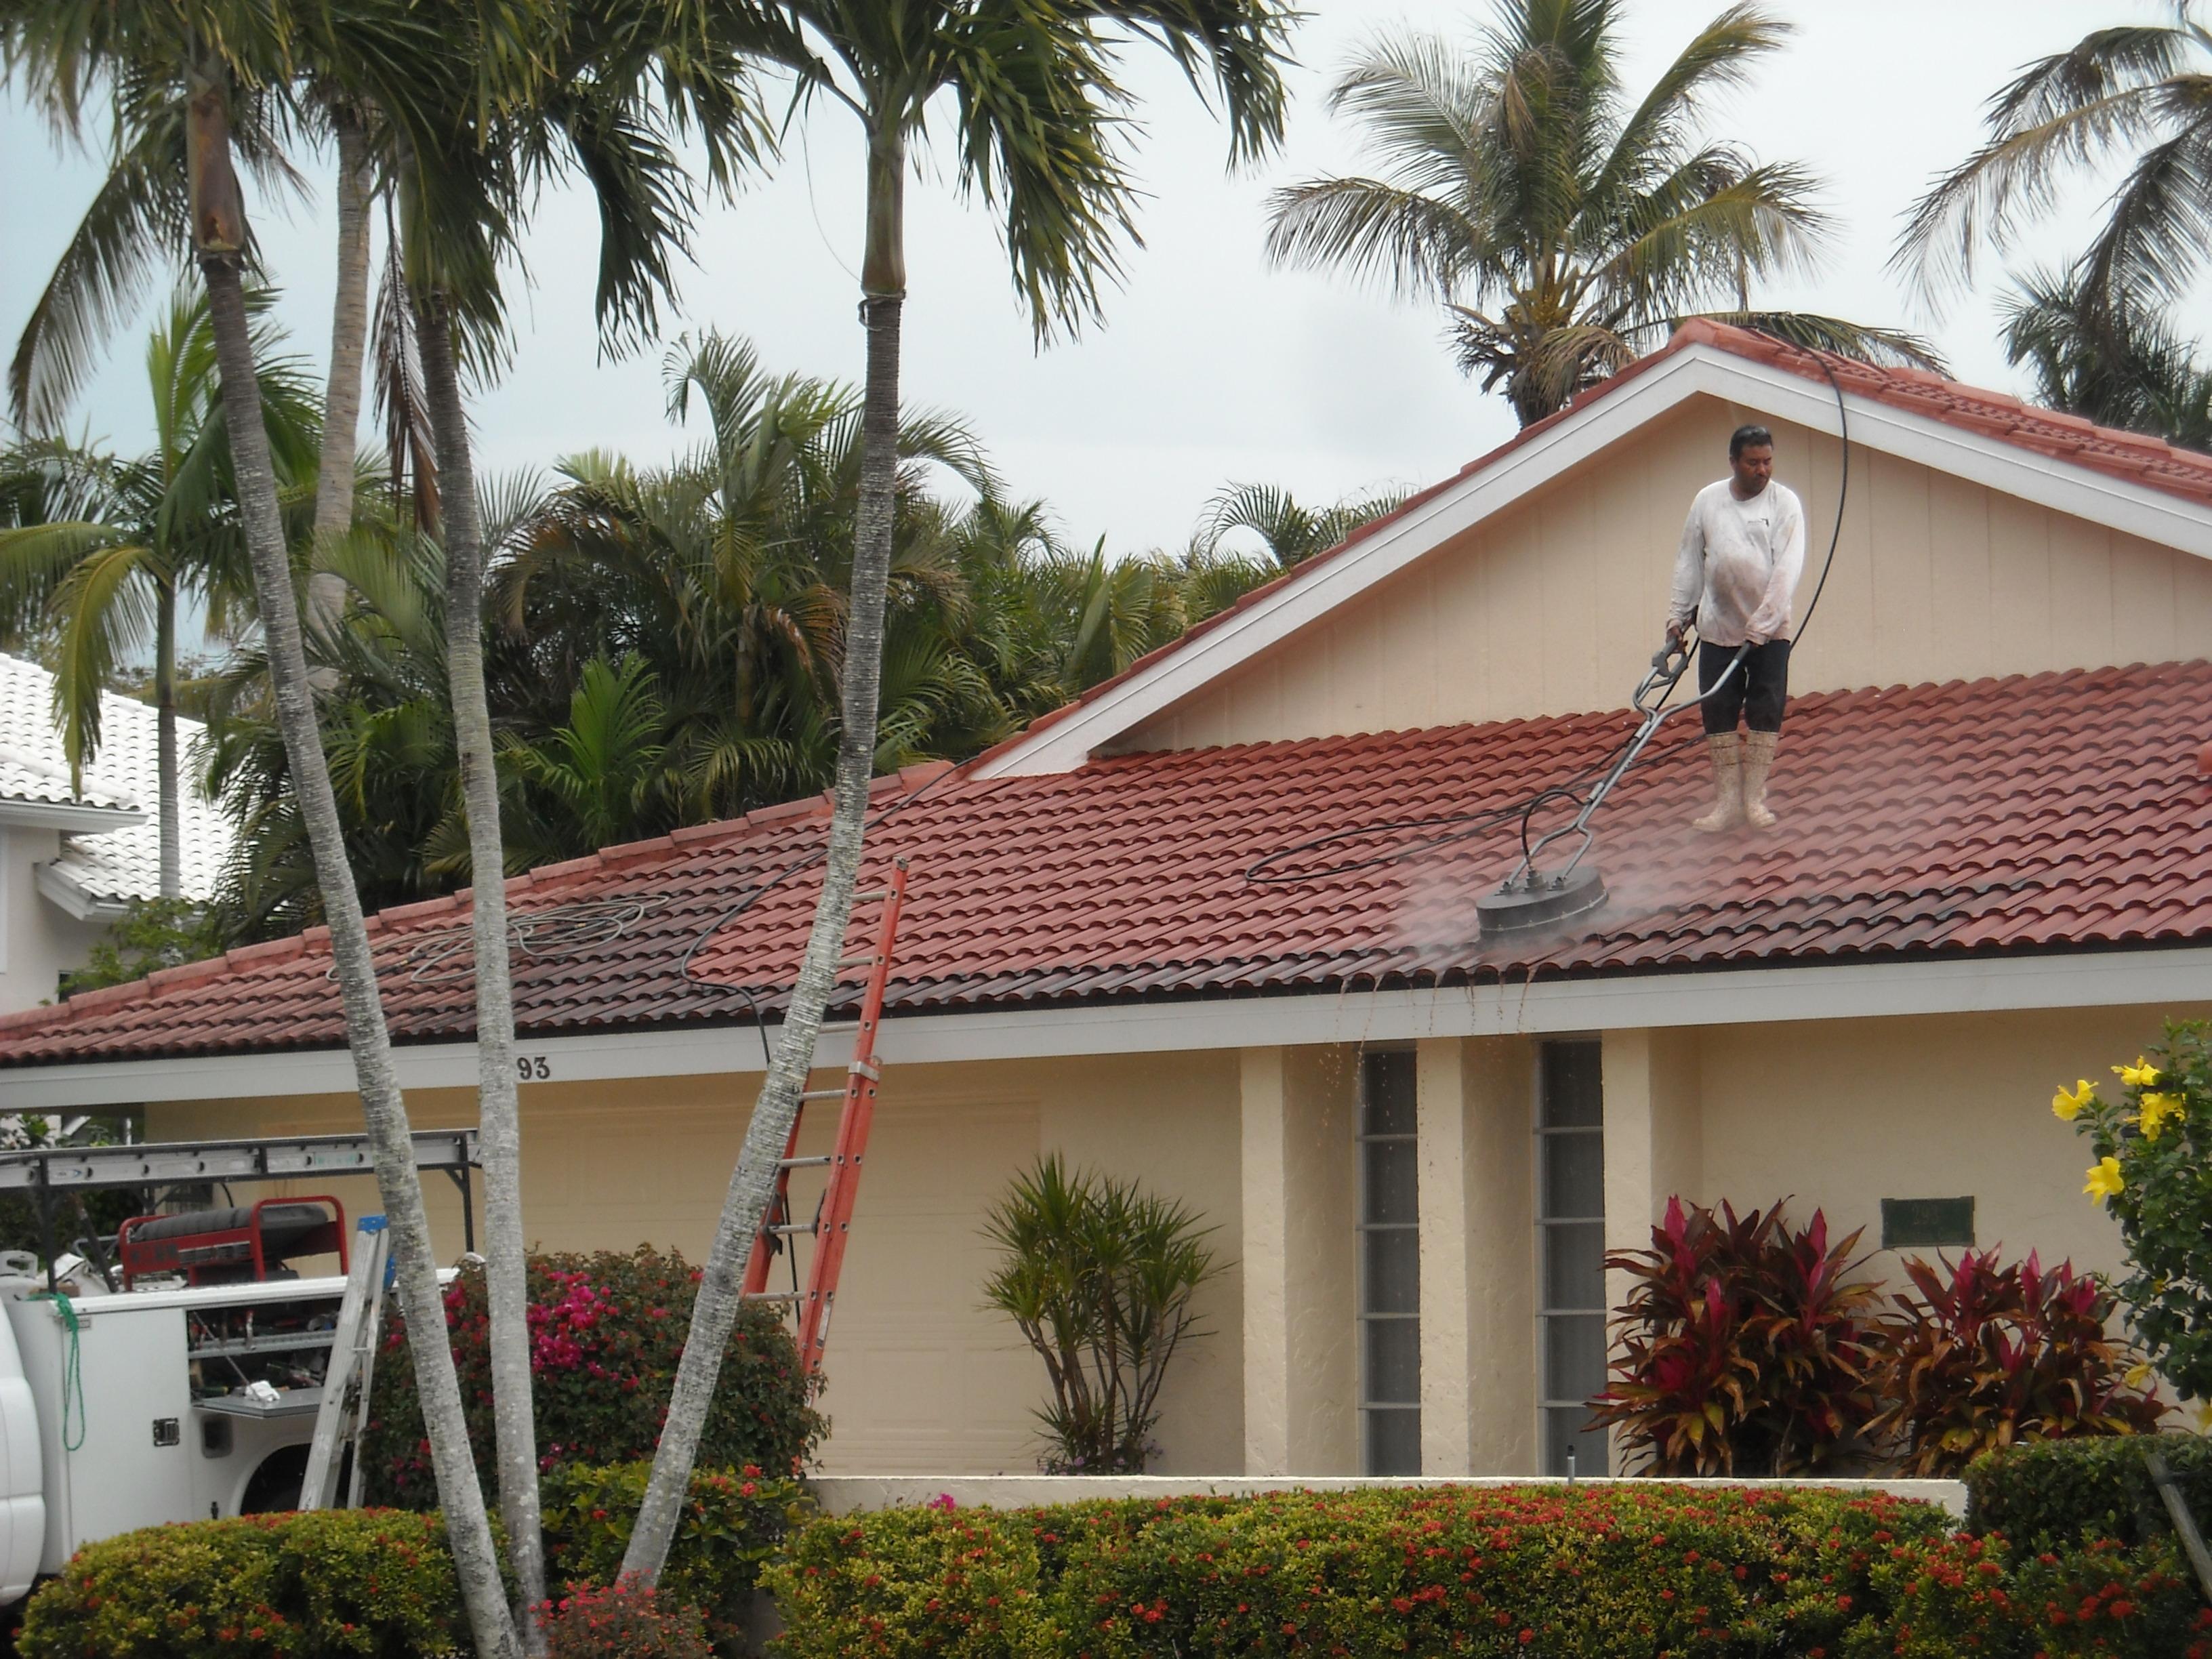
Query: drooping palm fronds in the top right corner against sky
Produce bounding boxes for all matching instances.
[1891,0,2212,323]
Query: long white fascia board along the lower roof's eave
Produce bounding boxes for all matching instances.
[0,947,2212,1111]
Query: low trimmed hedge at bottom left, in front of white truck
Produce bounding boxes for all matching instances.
[16,1509,469,1659]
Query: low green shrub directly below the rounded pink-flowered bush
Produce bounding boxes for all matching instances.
[537,1462,812,1652]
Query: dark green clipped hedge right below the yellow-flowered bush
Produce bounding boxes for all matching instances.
[1967,1433,2212,1549]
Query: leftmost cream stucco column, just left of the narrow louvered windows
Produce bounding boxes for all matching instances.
[1241,1048,1358,1475]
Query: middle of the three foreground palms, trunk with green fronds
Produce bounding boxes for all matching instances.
[376,0,765,1615]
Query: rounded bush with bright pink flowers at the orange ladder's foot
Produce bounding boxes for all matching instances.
[363,1248,827,1509]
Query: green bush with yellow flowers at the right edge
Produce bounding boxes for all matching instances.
[2051,1020,2212,1400]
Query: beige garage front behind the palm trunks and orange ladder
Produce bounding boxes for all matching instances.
[148,1055,1243,1473]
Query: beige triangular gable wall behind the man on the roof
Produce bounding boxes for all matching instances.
[1113,398,2212,750]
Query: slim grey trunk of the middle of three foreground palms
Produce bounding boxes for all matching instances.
[416,283,546,1652]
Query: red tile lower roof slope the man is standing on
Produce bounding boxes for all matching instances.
[0,661,2212,1066]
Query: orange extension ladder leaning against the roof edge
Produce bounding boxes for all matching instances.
[745,858,907,1374]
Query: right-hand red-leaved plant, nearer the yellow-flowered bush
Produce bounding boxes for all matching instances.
[1869,1248,2170,1477]
